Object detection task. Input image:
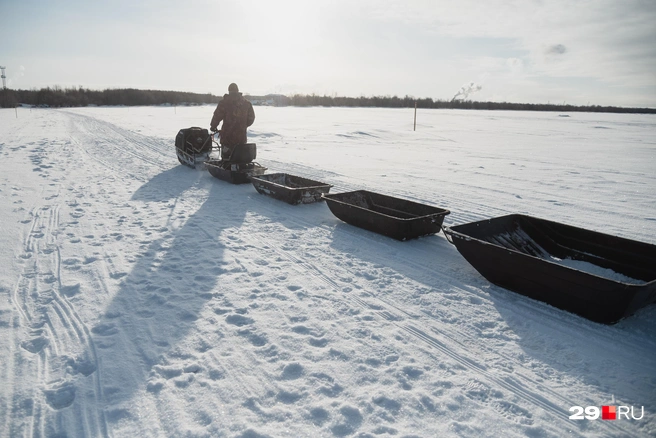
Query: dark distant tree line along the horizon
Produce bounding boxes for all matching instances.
[0,87,656,114]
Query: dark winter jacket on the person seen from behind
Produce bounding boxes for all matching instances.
[210,92,255,146]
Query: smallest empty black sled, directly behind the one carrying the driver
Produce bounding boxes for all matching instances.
[251,173,332,205]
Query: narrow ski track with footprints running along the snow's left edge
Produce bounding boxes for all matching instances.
[3,130,107,436]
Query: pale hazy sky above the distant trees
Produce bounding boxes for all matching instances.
[0,0,656,107]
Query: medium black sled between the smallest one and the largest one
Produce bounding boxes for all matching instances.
[323,190,450,240]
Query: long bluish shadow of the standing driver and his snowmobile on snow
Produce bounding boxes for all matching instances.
[92,166,249,412]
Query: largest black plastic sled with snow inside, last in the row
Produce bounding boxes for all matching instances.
[444,215,656,324]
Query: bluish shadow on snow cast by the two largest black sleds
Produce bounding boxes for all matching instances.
[331,223,656,418]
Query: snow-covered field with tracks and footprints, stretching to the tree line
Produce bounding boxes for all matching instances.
[0,106,656,438]
